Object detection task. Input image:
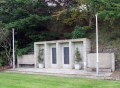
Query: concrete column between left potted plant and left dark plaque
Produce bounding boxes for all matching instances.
[44,43,51,68]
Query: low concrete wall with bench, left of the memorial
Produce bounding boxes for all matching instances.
[17,54,35,67]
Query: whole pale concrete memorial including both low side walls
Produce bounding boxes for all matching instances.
[17,38,115,72]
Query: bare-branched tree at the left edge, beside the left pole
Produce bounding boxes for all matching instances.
[0,28,12,65]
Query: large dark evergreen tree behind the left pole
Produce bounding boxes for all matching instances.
[0,0,51,55]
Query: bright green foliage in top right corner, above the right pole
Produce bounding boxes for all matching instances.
[93,0,120,25]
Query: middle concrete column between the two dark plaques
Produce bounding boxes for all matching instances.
[56,43,62,68]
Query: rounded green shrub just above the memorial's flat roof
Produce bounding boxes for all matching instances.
[72,25,85,39]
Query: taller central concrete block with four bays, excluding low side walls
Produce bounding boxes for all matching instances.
[34,38,91,70]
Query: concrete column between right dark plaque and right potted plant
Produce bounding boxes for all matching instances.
[69,41,75,69]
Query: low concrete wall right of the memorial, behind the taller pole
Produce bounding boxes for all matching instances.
[87,53,115,71]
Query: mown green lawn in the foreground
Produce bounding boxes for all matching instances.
[0,72,120,88]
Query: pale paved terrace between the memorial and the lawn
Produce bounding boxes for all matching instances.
[5,68,112,79]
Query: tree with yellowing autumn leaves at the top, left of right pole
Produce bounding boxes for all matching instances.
[49,0,93,26]
